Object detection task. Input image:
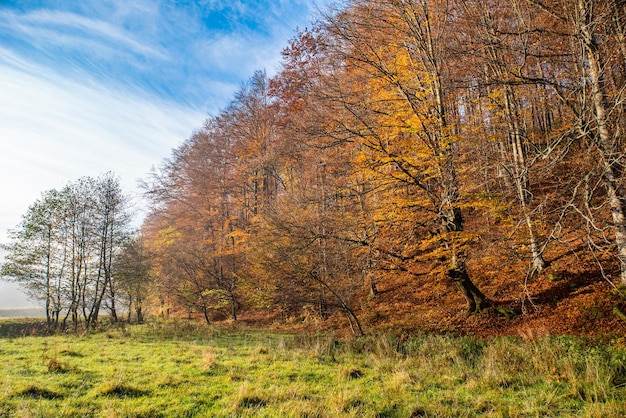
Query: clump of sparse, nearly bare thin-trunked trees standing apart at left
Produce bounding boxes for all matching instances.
[0,173,145,329]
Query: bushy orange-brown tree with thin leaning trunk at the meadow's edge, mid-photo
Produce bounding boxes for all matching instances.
[248,112,363,335]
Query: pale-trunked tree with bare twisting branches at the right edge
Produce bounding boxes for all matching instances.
[526,0,626,284]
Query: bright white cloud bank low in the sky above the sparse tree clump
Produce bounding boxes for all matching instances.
[0,56,205,242]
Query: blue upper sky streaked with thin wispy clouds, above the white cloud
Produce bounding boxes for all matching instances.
[0,0,334,111]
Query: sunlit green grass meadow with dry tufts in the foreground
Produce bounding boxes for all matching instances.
[0,321,626,417]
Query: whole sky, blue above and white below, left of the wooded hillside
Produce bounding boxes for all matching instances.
[0,0,329,309]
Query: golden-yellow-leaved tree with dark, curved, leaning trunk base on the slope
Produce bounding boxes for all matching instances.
[325,0,488,312]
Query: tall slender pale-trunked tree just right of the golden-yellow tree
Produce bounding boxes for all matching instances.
[456,0,546,272]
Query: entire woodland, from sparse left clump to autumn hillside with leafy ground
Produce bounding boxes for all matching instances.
[2,0,626,335]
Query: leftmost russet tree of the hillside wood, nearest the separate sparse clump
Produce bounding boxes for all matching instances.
[144,128,242,321]
